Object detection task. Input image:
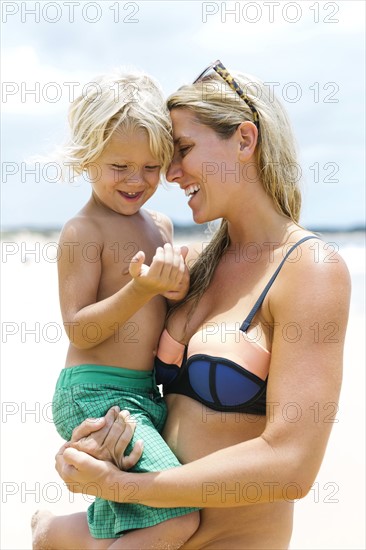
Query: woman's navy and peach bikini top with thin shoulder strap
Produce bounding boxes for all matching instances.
[155,235,318,415]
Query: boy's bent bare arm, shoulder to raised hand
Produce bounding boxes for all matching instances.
[58,218,183,349]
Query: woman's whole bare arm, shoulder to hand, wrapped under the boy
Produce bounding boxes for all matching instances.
[57,246,350,507]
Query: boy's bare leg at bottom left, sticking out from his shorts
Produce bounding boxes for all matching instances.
[32,510,118,550]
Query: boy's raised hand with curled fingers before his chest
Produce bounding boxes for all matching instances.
[129,243,188,299]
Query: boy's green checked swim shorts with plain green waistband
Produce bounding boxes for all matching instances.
[52,365,196,539]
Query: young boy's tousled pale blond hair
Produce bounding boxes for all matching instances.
[60,69,173,175]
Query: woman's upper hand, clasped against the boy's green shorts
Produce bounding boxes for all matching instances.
[63,407,143,470]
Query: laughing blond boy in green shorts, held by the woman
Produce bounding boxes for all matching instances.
[33,73,198,550]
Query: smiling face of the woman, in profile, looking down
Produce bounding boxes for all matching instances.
[166,108,240,223]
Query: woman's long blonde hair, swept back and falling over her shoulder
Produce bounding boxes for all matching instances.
[167,73,301,323]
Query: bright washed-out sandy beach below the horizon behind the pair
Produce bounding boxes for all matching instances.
[0,233,366,550]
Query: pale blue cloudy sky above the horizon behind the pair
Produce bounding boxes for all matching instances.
[1,0,365,229]
